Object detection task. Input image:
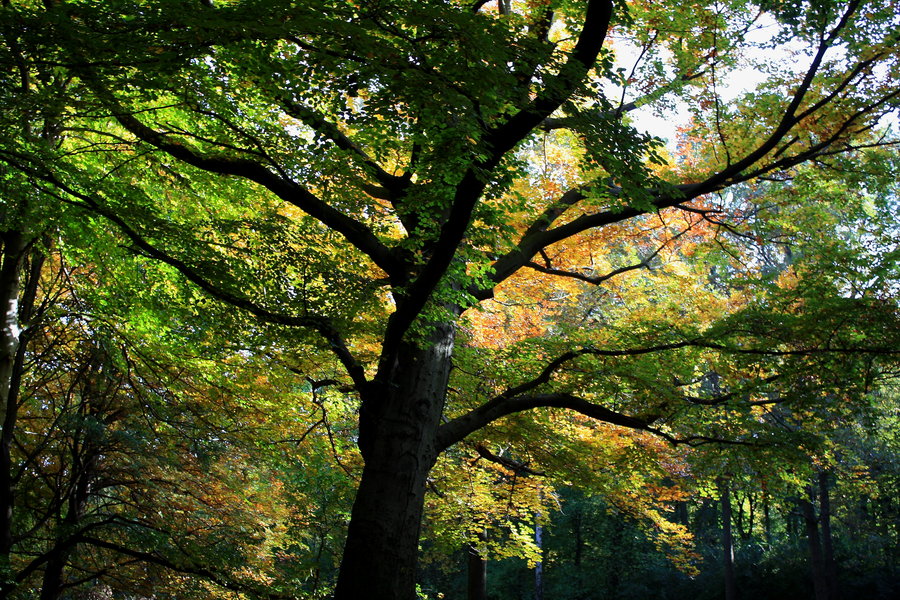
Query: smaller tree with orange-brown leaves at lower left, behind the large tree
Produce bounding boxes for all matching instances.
[0,240,308,600]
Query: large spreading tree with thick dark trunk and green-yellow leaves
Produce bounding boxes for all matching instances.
[0,0,900,600]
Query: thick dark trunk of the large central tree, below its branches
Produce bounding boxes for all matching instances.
[335,324,455,600]
